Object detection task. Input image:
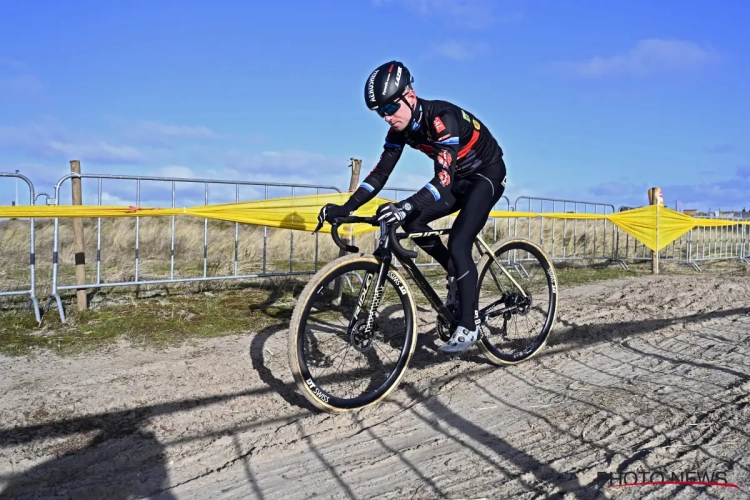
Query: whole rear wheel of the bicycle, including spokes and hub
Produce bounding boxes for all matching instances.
[477,238,557,365]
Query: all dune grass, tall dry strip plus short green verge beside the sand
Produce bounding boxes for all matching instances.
[0,216,748,355]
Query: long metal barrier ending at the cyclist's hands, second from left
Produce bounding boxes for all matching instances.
[47,173,341,322]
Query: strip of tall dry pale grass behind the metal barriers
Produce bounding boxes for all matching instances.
[0,216,742,297]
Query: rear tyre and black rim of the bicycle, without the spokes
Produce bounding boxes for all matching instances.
[476,237,558,365]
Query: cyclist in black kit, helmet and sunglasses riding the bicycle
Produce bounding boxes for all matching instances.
[318,61,505,354]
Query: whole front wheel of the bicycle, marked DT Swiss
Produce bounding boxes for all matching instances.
[288,254,417,413]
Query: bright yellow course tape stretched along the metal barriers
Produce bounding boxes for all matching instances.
[0,193,750,251]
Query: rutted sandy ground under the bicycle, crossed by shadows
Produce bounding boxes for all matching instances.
[0,275,750,499]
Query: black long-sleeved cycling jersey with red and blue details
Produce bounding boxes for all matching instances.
[345,98,505,210]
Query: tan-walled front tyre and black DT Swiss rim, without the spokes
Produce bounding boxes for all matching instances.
[287,253,417,413]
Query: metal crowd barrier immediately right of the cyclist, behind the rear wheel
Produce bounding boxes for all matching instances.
[514,196,624,266]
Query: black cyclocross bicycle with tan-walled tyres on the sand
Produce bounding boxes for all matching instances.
[288,216,557,413]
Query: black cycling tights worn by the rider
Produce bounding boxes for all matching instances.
[403,162,505,330]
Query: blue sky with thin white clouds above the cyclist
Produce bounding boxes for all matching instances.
[0,0,750,210]
